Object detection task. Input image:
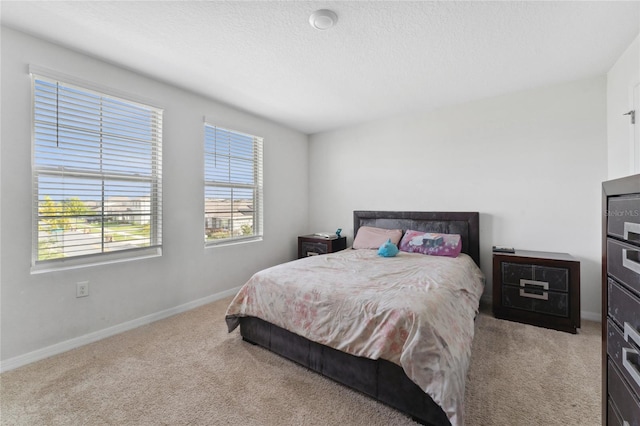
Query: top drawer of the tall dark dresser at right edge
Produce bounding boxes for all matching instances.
[607,194,640,244]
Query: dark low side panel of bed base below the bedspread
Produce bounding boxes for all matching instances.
[240,317,451,426]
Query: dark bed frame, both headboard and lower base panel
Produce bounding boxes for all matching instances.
[240,211,480,426]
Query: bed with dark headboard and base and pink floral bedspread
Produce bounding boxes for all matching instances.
[226,211,484,425]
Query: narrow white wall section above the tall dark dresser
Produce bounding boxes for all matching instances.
[607,35,640,179]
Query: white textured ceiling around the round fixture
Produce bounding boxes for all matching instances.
[0,0,640,133]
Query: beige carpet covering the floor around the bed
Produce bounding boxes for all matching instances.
[0,299,600,426]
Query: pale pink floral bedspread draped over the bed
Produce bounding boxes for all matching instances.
[226,249,484,425]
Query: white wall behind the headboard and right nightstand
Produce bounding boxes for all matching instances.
[309,76,607,319]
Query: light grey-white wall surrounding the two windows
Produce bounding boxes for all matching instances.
[0,28,308,365]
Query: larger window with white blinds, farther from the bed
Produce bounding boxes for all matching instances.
[33,74,162,265]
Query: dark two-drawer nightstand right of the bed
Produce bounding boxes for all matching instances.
[493,250,580,334]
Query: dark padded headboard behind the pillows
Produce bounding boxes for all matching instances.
[353,210,480,266]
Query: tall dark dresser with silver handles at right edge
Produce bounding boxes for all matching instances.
[602,175,640,426]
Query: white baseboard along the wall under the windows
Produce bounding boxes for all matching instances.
[0,287,240,373]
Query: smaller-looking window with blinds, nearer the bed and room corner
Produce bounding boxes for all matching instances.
[204,124,262,245]
